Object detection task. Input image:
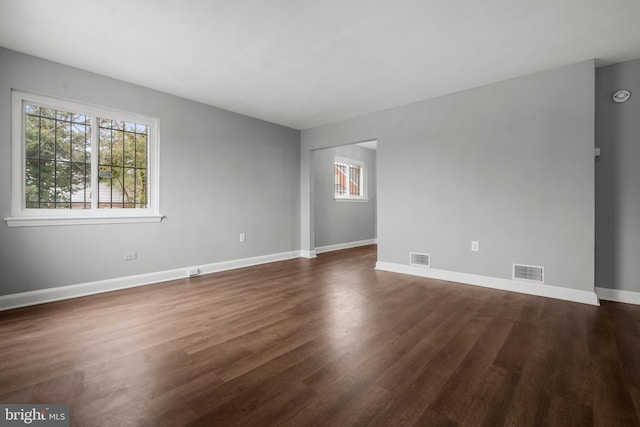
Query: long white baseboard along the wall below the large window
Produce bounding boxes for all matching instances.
[0,251,301,311]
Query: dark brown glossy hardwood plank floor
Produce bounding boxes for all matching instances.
[0,246,640,426]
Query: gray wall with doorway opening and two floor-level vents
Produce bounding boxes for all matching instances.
[301,61,595,291]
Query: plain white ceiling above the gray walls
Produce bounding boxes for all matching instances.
[0,0,640,129]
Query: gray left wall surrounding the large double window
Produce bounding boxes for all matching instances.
[0,49,300,295]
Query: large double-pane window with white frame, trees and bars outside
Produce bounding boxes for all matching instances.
[6,91,161,226]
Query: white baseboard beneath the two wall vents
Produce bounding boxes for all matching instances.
[376,261,600,305]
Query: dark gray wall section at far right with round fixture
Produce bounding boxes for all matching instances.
[596,60,640,292]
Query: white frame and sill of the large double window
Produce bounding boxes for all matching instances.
[5,90,162,227]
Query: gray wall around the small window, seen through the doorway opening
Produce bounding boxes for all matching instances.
[313,145,376,247]
